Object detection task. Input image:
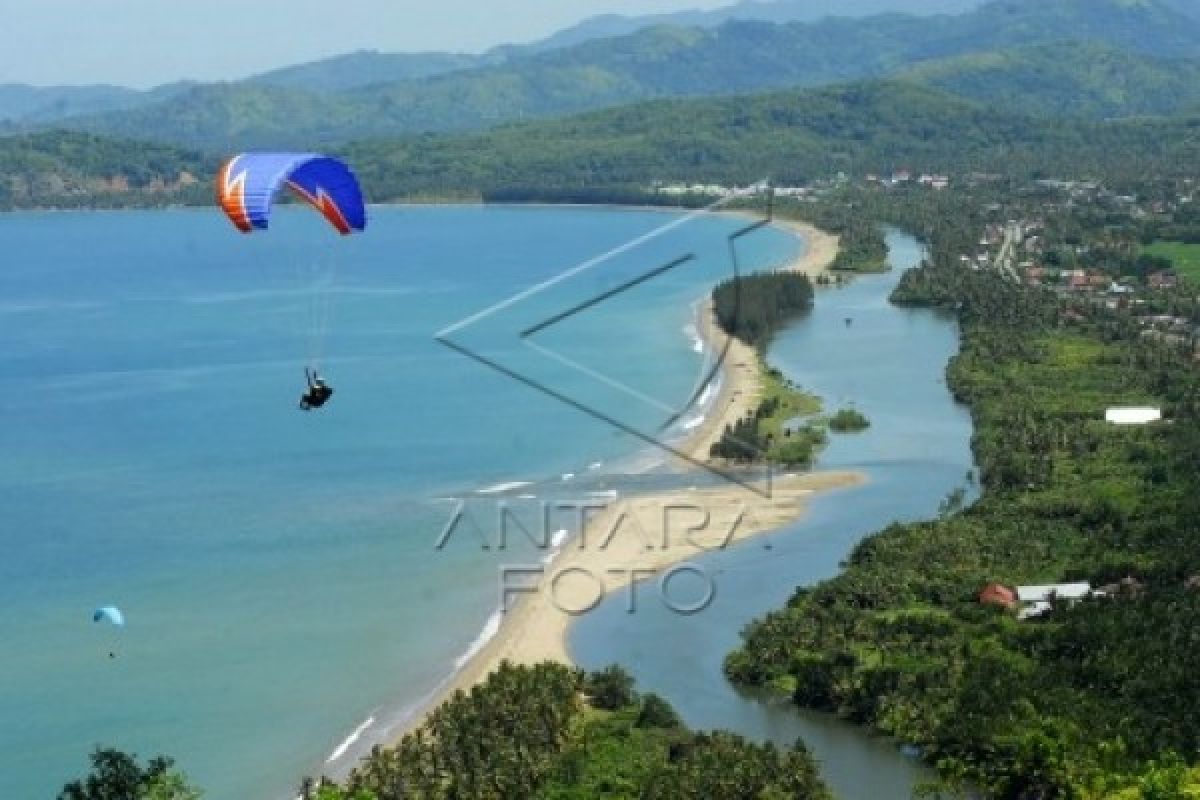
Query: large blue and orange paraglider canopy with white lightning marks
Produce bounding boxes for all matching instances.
[217,152,367,235]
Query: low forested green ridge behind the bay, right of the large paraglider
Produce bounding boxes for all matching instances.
[343,82,1200,200]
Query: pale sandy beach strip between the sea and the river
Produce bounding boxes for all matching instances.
[376,212,844,744]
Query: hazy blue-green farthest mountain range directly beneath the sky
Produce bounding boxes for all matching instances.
[46,0,1200,151]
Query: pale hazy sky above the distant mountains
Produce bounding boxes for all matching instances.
[0,0,733,86]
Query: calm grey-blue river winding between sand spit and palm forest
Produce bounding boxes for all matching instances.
[570,233,973,800]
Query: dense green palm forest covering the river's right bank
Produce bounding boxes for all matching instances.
[726,190,1200,798]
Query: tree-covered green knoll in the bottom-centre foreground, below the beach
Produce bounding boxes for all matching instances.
[301,663,829,800]
